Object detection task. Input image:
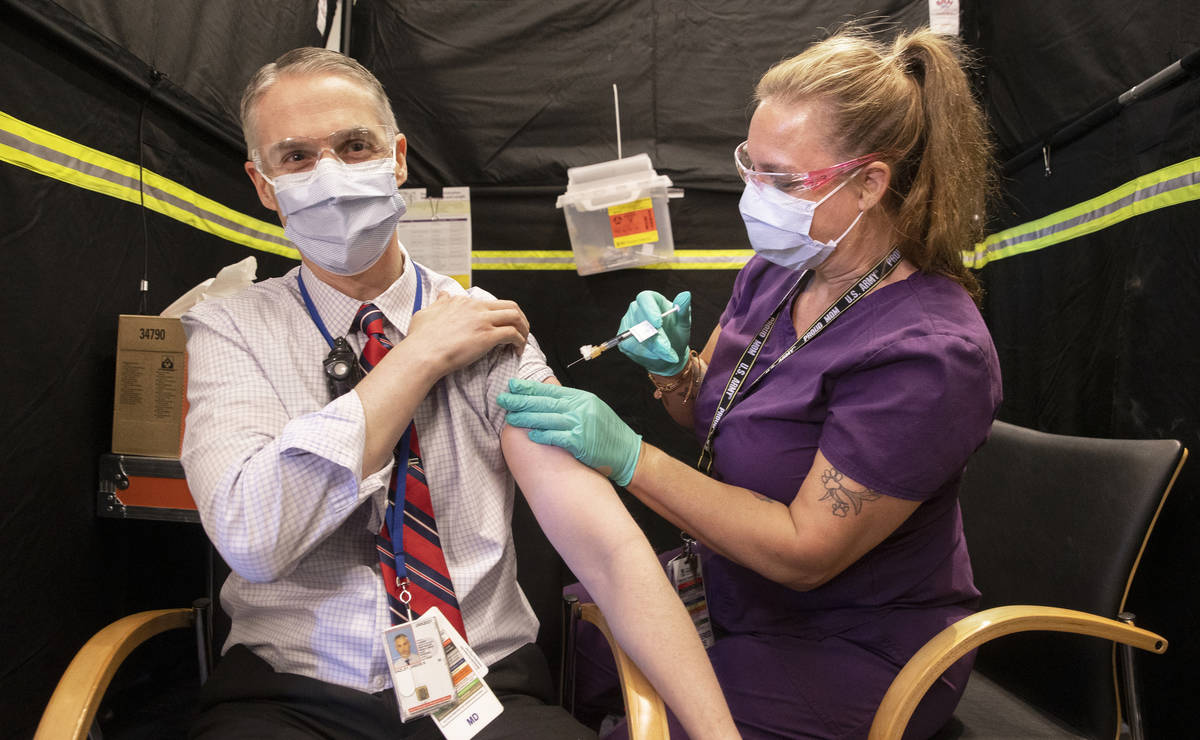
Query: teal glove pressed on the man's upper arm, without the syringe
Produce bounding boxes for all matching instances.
[496,378,642,486]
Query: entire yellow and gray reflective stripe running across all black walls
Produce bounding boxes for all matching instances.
[0,112,1200,270]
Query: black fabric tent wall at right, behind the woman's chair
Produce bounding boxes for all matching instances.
[967,0,1200,738]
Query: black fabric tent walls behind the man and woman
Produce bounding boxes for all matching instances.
[0,0,1200,738]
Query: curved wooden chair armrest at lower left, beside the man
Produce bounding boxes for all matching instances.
[34,609,194,740]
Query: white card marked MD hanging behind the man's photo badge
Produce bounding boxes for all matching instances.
[425,607,504,740]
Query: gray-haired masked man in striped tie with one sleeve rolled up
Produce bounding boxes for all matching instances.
[182,49,736,740]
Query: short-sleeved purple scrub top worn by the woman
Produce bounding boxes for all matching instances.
[696,257,1001,662]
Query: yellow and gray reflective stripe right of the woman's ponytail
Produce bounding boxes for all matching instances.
[962,157,1200,269]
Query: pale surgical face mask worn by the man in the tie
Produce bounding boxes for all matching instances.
[263,157,407,275]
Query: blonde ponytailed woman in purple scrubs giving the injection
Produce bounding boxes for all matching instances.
[500,29,1001,738]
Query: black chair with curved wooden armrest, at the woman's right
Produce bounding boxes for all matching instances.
[871,421,1187,740]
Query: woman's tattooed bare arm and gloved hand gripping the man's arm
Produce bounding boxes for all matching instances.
[497,379,917,591]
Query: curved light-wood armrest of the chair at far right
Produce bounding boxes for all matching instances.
[869,606,1166,740]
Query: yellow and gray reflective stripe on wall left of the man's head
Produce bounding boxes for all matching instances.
[0,112,300,259]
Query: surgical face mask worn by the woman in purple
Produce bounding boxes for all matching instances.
[738,178,863,271]
